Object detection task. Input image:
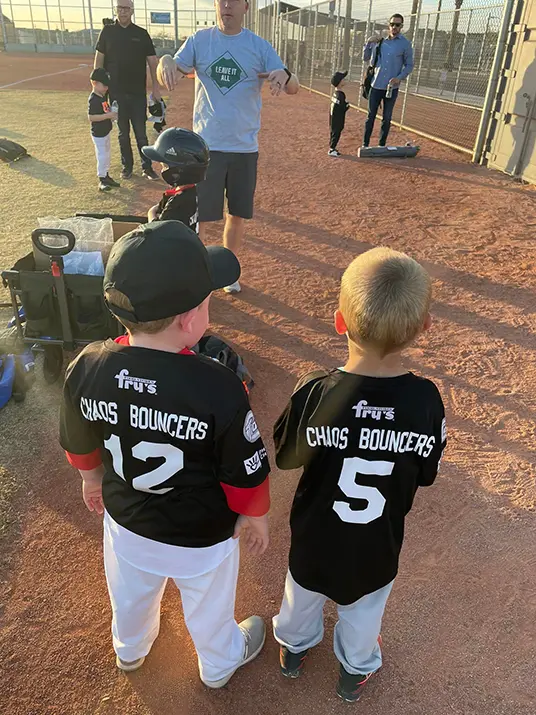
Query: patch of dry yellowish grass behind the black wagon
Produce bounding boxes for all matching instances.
[0,90,156,280]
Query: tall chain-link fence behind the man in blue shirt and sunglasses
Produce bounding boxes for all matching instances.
[259,0,503,152]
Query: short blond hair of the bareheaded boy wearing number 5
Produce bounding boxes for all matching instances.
[339,248,432,357]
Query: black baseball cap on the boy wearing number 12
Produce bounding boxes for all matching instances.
[104,221,240,323]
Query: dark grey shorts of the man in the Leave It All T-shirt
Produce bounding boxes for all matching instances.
[197,151,259,221]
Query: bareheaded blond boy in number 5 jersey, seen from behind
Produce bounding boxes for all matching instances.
[274,248,446,702]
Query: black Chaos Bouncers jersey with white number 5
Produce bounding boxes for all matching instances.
[274,370,446,605]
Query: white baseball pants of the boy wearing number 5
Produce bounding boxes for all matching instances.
[273,571,394,675]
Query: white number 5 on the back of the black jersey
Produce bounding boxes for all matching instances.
[333,457,395,524]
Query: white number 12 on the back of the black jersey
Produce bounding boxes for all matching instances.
[104,434,184,494]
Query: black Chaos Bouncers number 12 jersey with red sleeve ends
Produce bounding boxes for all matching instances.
[60,338,269,547]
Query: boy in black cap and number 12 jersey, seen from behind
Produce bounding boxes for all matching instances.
[60,221,269,688]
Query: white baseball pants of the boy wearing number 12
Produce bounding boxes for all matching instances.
[104,535,244,681]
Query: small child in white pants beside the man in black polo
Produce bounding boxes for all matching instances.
[87,67,120,191]
